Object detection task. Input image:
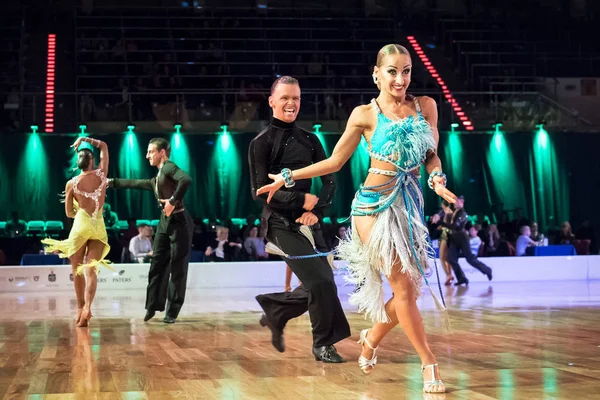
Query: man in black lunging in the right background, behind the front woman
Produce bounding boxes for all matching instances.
[441,196,492,286]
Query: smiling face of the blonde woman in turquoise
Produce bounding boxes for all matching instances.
[373,54,412,97]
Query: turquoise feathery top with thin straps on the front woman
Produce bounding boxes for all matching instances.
[369,99,435,172]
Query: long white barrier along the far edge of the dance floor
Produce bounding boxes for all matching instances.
[0,256,600,292]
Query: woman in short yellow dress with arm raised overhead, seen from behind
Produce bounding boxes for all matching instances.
[42,138,110,327]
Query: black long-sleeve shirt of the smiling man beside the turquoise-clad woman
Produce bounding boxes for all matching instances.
[248,118,335,233]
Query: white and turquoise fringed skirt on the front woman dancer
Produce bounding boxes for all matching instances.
[337,173,433,323]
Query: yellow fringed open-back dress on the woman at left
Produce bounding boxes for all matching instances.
[42,169,114,275]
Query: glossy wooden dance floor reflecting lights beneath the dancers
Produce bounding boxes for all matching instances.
[0,281,600,400]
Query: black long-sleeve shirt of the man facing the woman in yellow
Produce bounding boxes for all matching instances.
[112,160,192,211]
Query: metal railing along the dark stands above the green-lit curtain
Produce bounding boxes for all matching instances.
[9,90,599,131]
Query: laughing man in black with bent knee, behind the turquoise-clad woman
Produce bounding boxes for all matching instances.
[249,76,350,363]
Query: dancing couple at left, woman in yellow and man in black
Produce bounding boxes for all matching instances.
[42,137,194,327]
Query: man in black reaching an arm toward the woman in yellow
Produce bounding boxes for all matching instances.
[110,138,194,324]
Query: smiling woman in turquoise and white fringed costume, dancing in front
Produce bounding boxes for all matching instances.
[257,44,456,393]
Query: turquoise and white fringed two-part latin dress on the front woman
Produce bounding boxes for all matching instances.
[337,98,436,322]
